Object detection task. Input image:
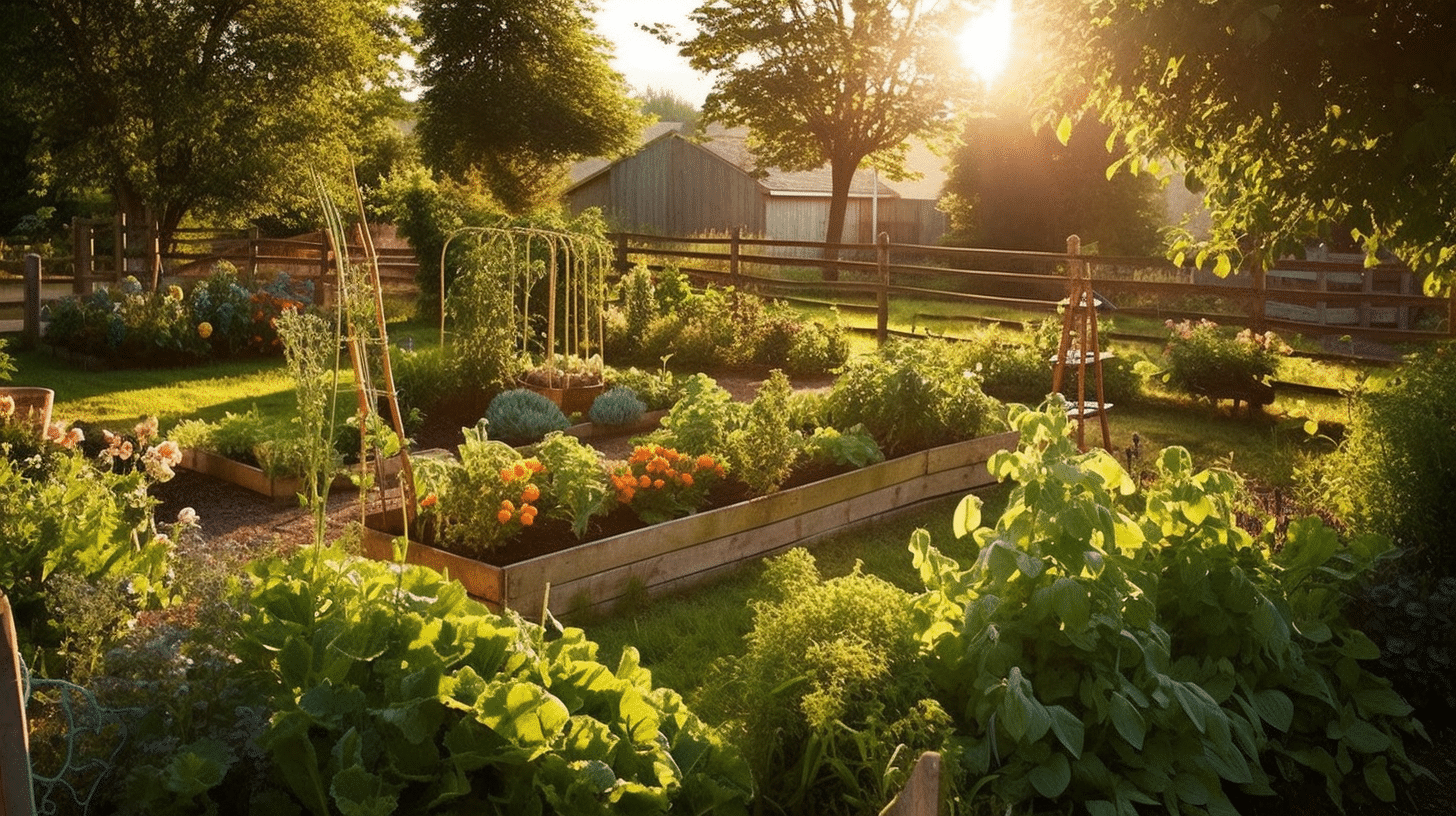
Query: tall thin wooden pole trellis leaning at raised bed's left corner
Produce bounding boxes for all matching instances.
[320,177,418,529]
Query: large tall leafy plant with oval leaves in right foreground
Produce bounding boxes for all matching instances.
[911,405,1423,815]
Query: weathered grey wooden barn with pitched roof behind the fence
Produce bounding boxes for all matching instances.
[566,122,945,243]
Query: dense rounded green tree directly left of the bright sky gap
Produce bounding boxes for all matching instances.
[416,0,642,211]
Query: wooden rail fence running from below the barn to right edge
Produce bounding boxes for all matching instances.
[612,233,1456,342]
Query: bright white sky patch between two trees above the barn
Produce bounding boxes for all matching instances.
[596,0,712,108]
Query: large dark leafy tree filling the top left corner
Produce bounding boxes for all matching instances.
[0,0,405,260]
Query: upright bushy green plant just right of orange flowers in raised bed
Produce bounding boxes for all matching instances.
[727,369,804,495]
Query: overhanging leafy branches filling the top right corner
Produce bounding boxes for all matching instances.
[1034,0,1456,280]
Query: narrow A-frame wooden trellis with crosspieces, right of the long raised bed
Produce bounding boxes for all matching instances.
[1051,235,1112,450]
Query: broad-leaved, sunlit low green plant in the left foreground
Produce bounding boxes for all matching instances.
[107,548,753,816]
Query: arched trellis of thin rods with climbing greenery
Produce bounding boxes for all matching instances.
[440,227,616,376]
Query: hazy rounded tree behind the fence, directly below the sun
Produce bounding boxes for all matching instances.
[941,101,1163,255]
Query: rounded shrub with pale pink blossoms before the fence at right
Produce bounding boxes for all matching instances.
[1163,321,1290,395]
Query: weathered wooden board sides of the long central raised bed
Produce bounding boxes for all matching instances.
[364,431,1018,618]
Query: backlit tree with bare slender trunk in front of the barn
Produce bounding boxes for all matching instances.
[680,0,976,277]
